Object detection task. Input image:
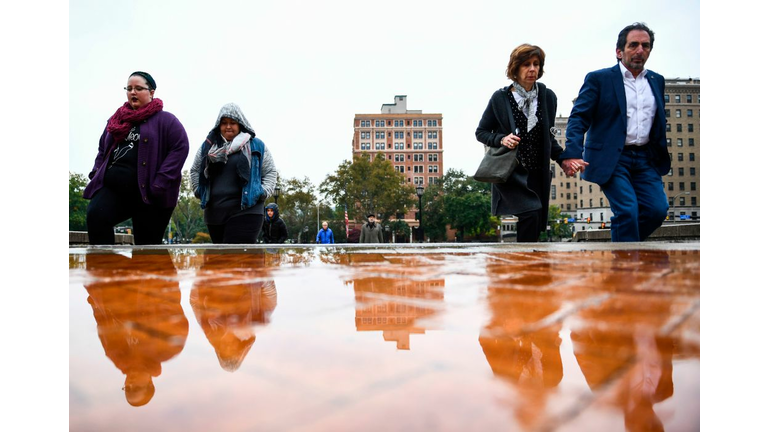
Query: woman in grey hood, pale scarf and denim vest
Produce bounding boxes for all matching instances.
[190,103,277,244]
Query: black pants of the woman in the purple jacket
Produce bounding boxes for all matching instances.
[86,186,173,245]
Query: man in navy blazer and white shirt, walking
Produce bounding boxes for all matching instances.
[558,23,671,242]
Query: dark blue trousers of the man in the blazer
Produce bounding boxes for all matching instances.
[600,148,669,242]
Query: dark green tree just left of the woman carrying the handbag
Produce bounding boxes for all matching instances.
[442,168,498,239]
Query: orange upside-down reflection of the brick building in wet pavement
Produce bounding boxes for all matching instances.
[353,277,445,350]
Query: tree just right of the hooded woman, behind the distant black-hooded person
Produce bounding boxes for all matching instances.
[268,177,316,243]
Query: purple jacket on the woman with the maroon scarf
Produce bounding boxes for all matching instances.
[83,111,189,208]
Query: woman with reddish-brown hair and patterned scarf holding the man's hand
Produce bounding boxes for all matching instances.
[475,44,563,242]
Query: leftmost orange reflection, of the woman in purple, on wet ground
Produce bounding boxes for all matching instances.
[85,251,189,406]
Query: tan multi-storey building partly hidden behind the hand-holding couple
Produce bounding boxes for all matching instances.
[550,78,701,230]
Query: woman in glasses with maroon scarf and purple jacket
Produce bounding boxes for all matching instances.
[83,71,189,245]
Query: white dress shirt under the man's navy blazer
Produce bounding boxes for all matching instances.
[619,62,656,146]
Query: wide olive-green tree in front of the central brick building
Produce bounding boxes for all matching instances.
[320,153,417,222]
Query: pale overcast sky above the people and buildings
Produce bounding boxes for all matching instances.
[69,0,700,185]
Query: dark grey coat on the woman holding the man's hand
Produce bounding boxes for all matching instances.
[475,83,563,228]
